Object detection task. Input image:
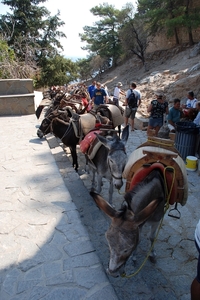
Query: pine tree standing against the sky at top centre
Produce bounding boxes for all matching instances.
[79,3,122,66]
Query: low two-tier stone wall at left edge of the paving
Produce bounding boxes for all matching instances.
[0,79,35,115]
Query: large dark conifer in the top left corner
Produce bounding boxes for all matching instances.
[0,0,65,66]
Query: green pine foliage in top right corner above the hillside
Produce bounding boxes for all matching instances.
[138,0,200,45]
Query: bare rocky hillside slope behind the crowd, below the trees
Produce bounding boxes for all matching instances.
[97,43,200,117]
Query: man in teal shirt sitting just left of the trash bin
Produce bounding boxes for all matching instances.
[167,98,182,132]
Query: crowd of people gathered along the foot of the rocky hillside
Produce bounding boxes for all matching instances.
[85,81,200,136]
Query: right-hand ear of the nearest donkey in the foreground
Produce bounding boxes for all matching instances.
[132,199,160,226]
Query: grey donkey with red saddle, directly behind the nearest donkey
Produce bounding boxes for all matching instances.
[86,125,129,204]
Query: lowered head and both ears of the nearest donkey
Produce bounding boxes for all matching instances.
[90,192,159,277]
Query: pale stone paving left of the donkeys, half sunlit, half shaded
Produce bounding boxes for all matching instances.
[0,115,118,300]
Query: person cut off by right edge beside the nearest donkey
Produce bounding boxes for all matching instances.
[190,220,200,300]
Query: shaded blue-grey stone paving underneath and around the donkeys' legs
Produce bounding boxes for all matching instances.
[61,125,200,300]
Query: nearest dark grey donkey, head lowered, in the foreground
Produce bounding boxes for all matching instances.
[90,169,165,277]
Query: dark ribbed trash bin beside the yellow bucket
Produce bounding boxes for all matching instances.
[175,121,199,160]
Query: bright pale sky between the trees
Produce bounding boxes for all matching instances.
[0,0,136,60]
